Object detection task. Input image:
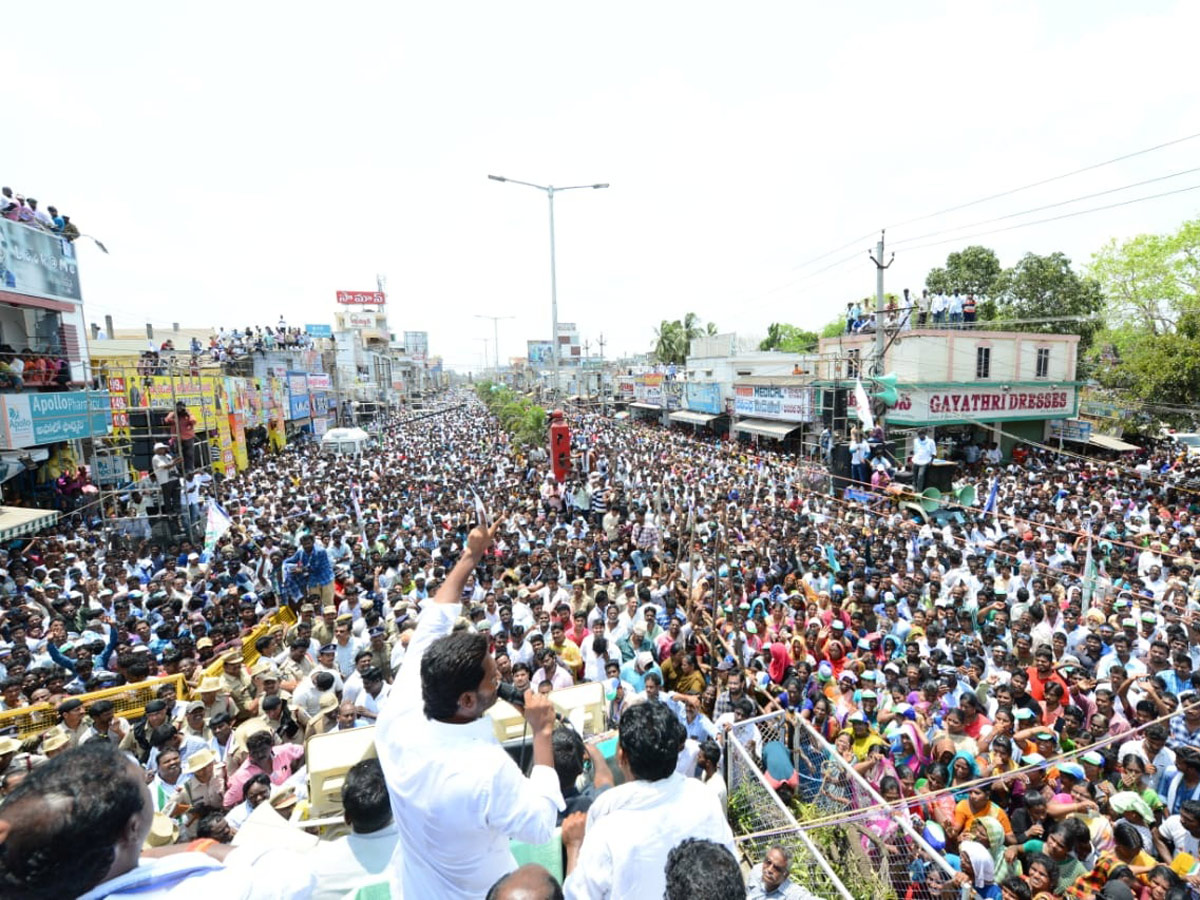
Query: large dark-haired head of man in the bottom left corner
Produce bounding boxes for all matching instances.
[0,742,146,900]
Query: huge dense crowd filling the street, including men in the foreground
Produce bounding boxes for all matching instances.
[0,395,1200,900]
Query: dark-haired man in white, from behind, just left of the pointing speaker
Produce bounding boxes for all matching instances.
[312,760,401,900]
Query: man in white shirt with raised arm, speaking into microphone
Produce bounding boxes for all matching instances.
[376,522,565,900]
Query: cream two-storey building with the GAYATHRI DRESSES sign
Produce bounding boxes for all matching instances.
[817,329,1081,457]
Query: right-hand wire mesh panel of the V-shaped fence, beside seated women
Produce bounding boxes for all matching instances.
[788,716,974,900]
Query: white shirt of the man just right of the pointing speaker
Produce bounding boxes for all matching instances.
[563,773,736,900]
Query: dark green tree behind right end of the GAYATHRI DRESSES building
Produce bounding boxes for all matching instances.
[992,252,1104,358]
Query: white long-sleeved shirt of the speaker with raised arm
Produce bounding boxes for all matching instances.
[376,604,565,900]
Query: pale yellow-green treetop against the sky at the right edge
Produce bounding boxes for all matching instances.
[1090,218,1200,335]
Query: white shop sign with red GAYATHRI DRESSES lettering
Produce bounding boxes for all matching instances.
[888,385,1078,425]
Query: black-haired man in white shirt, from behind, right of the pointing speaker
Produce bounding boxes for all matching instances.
[563,702,733,900]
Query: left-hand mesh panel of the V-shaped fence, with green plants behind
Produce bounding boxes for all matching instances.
[725,714,870,900]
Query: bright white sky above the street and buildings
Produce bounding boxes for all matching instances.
[9,0,1200,368]
